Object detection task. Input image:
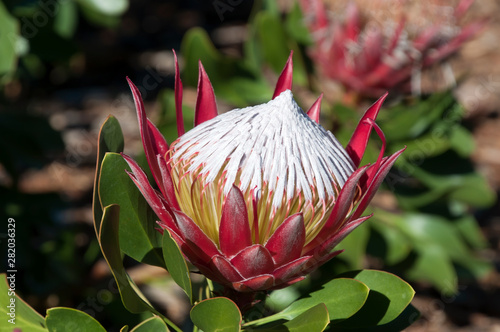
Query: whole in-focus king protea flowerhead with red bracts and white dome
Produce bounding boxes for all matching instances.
[123,50,402,292]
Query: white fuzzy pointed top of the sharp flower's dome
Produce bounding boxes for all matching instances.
[172,90,354,207]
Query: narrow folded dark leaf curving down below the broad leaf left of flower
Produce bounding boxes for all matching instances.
[99,205,181,332]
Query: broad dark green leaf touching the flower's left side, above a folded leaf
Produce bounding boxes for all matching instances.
[99,153,165,267]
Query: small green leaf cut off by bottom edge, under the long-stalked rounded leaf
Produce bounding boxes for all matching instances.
[256,303,330,332]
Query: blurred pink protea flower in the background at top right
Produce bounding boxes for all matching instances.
[301,0,484,97]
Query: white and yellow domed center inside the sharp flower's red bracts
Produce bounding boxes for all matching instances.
[170,90,354,244]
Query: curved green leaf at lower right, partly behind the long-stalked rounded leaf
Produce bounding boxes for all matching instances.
[340,270,415,328]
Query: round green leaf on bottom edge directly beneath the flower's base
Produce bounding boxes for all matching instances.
[190,297,241,332]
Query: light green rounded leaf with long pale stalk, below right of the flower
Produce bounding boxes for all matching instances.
[248,278,369,325]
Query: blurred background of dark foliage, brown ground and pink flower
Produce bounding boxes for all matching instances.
[0,0,500,331]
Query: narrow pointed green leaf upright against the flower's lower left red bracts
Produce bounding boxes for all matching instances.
[163,229,193,303]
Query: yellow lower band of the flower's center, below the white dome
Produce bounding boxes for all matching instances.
[170,147,359,245]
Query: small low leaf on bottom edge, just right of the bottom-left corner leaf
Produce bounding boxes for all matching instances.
[45,308,106,332]
